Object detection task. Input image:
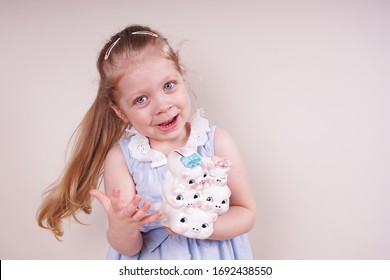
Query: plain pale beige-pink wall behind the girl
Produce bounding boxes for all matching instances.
[0,0,390,259]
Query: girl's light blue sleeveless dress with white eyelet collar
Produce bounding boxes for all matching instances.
[107,110,252,260]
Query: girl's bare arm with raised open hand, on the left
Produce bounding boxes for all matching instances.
[91,145,161,256]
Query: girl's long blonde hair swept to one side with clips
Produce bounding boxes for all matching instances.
[37,25,183,239]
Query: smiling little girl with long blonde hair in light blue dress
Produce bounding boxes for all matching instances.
[38,26,256,259]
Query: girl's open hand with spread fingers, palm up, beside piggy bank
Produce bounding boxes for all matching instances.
[90,188,162,234]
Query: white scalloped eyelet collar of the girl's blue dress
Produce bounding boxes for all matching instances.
[128,109,211,168]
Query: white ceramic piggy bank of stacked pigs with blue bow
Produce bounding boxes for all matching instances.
[156,147,231,239]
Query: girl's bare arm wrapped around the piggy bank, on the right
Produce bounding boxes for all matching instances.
[211,129,256,239]
